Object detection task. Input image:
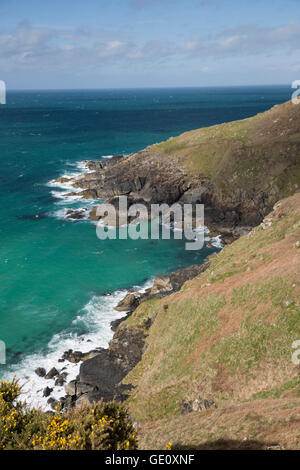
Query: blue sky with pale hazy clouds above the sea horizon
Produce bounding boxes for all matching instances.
[0,0,300,89]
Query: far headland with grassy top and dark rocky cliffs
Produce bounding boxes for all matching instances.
[69,102,300,235]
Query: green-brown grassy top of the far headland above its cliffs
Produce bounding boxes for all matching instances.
[151,102,300,200]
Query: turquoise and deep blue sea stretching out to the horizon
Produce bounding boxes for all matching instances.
[0,86,291,403]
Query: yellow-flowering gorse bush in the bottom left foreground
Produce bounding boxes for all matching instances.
[0,379,138,450]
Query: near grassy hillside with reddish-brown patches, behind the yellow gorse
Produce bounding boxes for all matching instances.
[120,193,300,448]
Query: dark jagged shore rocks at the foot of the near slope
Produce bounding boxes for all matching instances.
[35,262,209,409]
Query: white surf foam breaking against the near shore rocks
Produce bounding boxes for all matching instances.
[5,279,153,410]
